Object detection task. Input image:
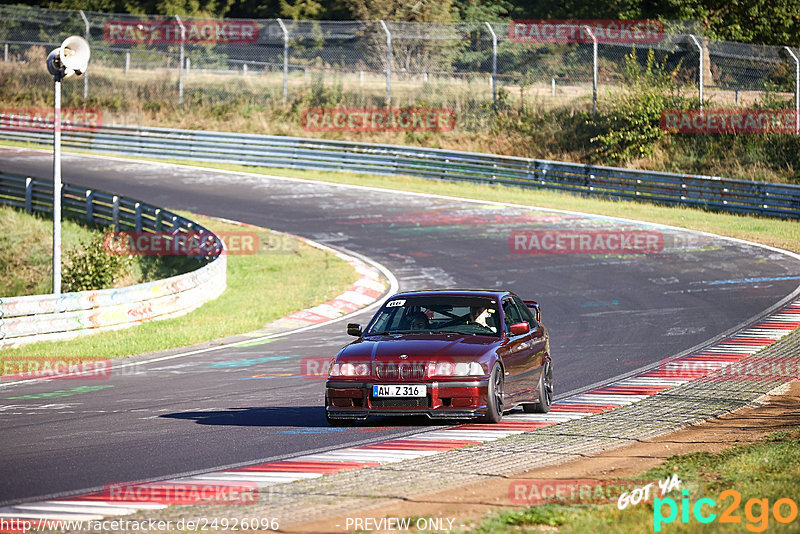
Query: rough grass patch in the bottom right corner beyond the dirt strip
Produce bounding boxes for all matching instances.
[470,428,800,534]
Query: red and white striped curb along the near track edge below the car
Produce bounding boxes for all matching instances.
[0,299,800,520]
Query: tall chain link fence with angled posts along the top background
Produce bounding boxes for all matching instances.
[0,6,800,134]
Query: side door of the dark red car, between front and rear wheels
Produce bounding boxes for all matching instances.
[498,297,535,402]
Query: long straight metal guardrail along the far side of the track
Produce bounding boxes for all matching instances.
[0,115,800,218]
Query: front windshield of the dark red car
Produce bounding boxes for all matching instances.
[364,295,501,337]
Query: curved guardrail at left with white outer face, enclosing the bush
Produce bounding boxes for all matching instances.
[0,173,227,348]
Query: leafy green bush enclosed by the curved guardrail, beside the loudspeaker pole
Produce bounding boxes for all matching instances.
[62,232,133,292]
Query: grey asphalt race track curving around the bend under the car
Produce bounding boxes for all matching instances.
[0,149,800,504]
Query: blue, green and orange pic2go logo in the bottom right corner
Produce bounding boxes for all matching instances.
[653,490,797,532]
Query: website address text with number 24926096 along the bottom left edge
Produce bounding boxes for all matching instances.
[0,517,280,532]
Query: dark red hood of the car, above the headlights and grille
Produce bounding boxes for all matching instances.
[338,334,500,362]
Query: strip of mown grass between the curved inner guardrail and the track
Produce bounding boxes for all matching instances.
[0,213,358,366]
